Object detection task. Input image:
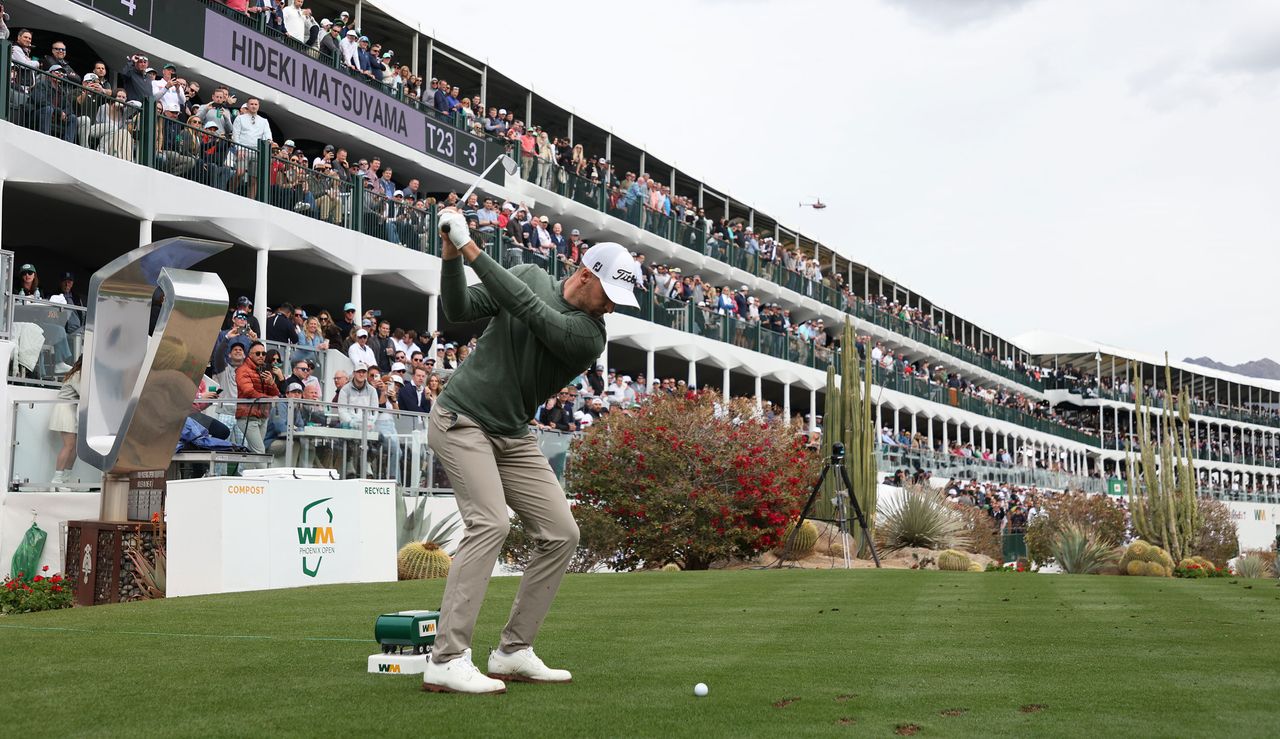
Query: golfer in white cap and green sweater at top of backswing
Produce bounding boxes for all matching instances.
[422,207,637,693]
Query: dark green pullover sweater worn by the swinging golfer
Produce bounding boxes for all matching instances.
[438,252,605,437]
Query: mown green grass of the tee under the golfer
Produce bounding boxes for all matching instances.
[0,570,1280,738]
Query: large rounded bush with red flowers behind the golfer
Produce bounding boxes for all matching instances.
[566,392,818,570]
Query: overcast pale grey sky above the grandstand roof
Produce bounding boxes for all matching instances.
[379,0,1280,364]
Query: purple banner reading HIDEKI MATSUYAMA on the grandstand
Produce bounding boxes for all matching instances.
[205,10,426,151]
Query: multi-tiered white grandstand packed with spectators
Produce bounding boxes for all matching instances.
[0,0,1280,548]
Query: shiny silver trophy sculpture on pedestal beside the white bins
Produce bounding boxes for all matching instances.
[77,238,230,521]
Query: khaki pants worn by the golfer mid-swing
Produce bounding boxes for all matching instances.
[426,403,577,665]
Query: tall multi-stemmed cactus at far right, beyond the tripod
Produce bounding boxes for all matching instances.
[1126,352,1201,562]
